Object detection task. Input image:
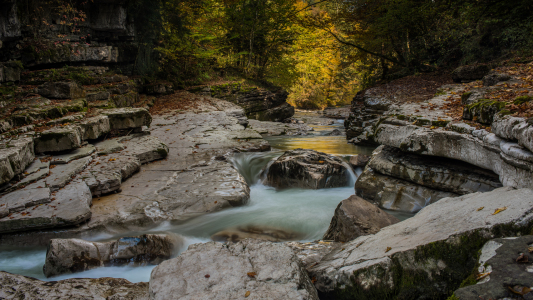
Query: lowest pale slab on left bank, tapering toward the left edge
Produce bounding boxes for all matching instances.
[0,183,92,233]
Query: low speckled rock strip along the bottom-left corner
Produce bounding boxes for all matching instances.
[0,272,148,300]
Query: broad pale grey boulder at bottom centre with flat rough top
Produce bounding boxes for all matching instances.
[150,240,318,300]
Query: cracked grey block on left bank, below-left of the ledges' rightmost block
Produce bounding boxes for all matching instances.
[77,153,141,197]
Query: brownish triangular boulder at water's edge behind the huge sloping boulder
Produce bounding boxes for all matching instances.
[324,195,400,242]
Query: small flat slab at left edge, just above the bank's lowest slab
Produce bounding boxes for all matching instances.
[0,188,50,213]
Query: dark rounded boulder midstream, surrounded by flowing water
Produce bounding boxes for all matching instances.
[264,149,350,189]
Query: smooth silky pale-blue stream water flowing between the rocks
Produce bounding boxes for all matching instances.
[0,116,413,282]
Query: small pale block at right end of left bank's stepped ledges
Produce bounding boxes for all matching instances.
[119,135,169,164]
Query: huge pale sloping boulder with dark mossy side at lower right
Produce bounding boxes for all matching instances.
[310,187,533,299]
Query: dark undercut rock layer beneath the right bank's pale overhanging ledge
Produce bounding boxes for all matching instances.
[368,146,502,195]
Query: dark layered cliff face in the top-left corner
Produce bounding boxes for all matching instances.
[0,0,152,74]
